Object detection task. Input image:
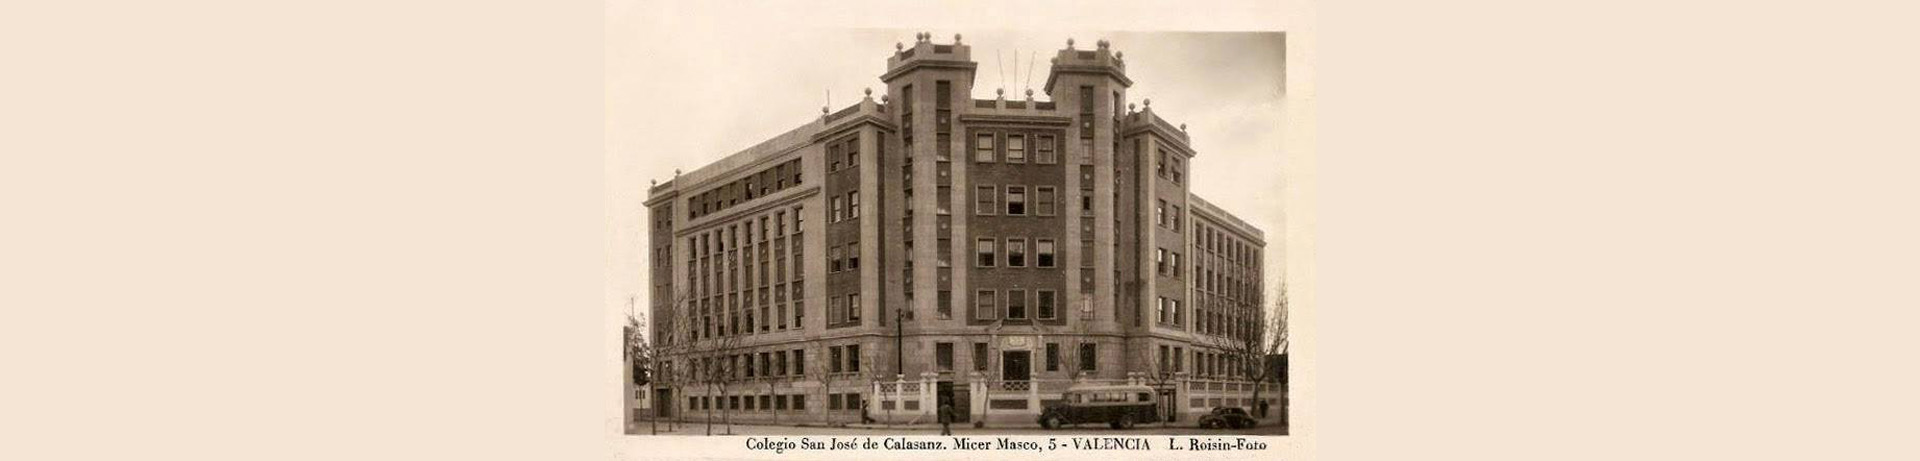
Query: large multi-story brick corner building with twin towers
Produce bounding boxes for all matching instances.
[645,35,1265,421]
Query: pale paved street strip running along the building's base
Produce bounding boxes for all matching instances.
[628,421,1283,436]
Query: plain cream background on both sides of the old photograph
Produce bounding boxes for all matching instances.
[0,2,1920,459]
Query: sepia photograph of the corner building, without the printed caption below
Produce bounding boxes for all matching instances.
[609,21,1290,436]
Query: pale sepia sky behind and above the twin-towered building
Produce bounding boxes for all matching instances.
[607,20,1284,328]
